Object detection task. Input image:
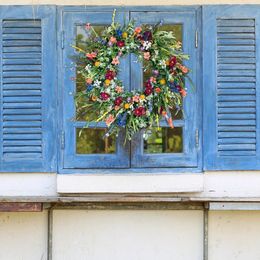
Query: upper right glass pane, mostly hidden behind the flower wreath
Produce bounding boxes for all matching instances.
[143,24,183,120]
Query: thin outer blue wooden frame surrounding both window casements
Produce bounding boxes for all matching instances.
[58,6,202,173]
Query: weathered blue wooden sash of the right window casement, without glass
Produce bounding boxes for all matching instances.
[131,8,201,168]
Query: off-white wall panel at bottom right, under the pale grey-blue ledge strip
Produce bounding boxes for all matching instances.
[209,211,260,260]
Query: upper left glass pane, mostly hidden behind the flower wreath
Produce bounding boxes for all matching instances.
[76,25,106,121]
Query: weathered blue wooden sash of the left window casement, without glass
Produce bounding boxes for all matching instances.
[60,9,130,169]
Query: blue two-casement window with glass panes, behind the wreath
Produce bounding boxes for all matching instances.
[61,8,200,169]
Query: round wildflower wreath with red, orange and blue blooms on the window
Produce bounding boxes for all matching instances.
[73,12,189,140]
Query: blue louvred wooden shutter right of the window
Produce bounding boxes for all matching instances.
[203,6,260,170]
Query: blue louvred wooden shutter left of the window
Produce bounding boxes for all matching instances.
[0,6,56,172]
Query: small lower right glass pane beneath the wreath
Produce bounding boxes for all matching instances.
[144,127,183,153]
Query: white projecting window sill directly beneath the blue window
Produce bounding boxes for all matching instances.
[57,173,203,194]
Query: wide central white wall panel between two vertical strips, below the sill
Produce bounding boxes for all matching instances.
[53,210,203,260]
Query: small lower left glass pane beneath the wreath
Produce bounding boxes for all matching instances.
[76,128,116,154]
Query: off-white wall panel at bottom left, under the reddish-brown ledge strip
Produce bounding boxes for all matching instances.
[0,211,48,260]
